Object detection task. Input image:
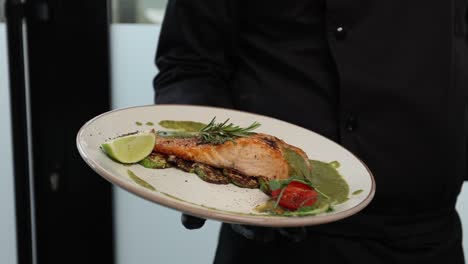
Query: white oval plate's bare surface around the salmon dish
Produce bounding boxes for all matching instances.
[76,105,375,227]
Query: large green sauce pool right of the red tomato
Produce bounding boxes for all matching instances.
[310,160,349,203]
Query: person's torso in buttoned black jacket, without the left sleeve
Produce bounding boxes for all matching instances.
[232,0,468,237]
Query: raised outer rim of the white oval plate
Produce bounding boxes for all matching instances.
[76,104,376,227]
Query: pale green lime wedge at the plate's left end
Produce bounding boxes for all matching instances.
[101,132,156,163]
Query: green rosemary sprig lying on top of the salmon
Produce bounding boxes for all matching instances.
[200,117,260,144]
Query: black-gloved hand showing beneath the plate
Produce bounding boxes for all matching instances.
[181,214,307,242]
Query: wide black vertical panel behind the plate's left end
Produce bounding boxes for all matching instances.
[27,0,113,264]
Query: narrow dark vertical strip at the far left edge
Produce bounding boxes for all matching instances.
[5,0,33,264]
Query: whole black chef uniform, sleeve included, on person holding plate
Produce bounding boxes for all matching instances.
[154,0,468,263]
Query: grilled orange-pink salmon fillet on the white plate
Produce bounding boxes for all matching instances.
[154,133,309,179]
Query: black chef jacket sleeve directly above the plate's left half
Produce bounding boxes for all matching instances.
[153,0,235,108]
